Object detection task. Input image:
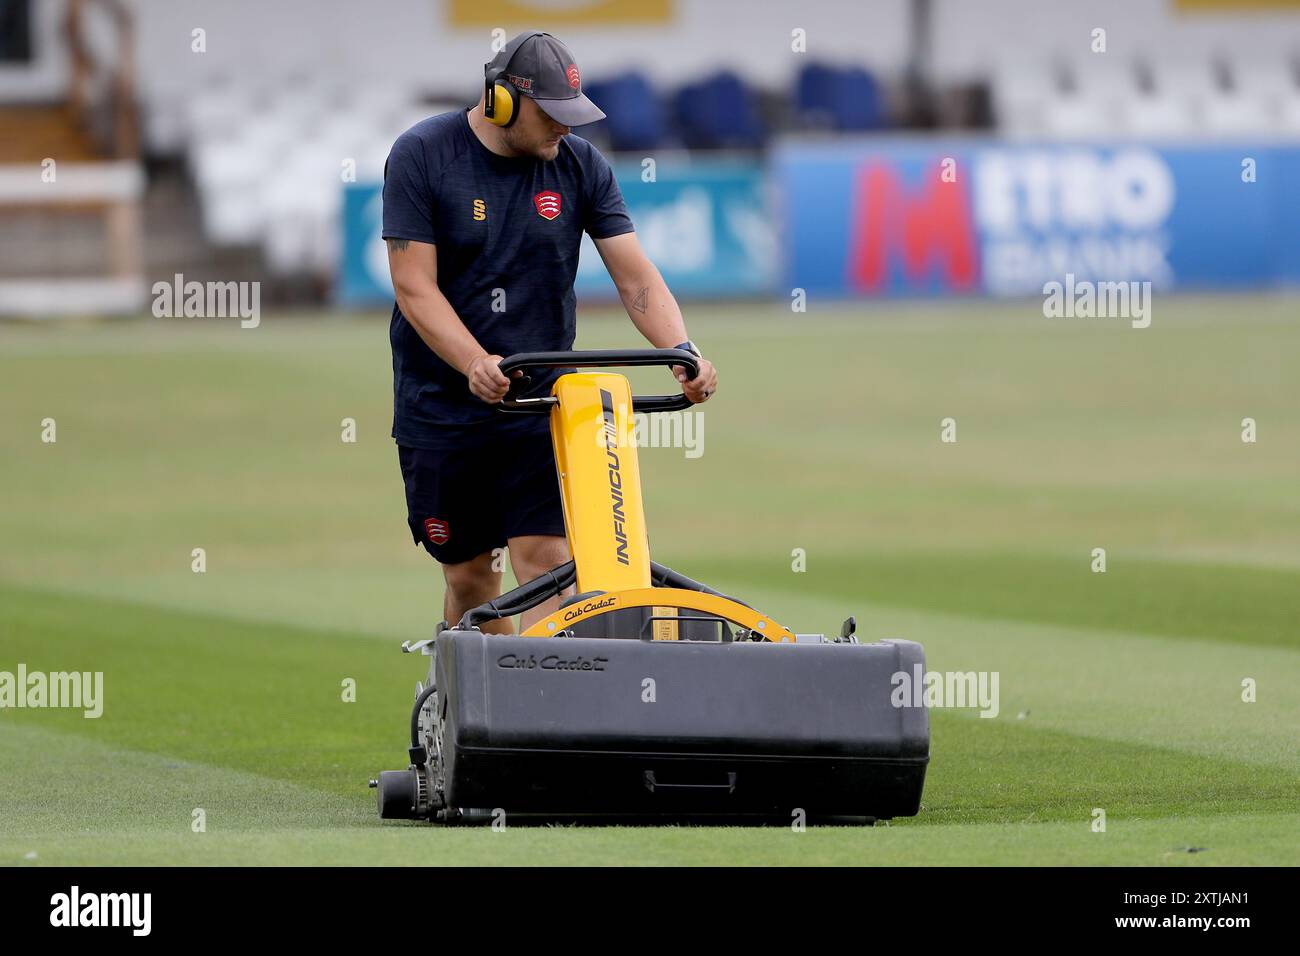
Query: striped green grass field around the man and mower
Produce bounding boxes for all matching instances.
[0,297,1300,865]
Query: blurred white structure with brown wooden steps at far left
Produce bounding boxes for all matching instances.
[0,0,144,315]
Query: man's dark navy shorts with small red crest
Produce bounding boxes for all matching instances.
[398,432,564,564]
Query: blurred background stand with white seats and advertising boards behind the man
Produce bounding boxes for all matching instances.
[0,0,1300,316]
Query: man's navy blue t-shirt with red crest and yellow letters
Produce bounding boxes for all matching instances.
[384,111,632,449]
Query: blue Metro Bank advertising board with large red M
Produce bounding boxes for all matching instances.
[772,140,1300,297]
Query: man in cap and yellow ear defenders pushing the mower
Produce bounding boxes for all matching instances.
[384,33,718,633]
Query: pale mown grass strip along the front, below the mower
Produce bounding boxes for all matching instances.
[0,727,1300,866]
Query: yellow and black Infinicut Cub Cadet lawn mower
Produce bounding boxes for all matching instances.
[371,349,930,825]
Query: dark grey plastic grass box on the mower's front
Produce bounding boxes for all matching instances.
[437,631,930,822]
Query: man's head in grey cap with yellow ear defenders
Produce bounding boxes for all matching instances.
[484,31,605,160]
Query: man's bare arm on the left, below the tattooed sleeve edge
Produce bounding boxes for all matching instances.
[387,239,510,402]
